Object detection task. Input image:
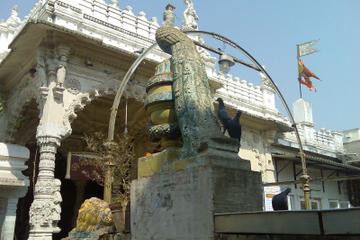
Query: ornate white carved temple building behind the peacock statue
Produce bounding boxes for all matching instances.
[0,0,360,240]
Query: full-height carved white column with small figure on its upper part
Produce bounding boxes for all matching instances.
[29,46,71,240]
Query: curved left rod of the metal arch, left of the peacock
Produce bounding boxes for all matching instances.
[107,43,157,142]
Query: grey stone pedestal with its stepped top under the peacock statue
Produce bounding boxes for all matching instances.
[130,138,262,240]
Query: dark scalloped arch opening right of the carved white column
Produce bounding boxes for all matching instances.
[54,92,154,239]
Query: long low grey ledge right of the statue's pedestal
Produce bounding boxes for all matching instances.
[215,208,360,236]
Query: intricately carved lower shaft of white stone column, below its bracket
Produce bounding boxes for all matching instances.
[29,130,61,240]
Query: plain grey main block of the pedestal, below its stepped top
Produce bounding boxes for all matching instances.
[130,165,262,240]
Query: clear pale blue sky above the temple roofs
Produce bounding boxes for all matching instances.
[0,0,360,131]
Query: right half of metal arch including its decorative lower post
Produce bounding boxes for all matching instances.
[186,30,310,209]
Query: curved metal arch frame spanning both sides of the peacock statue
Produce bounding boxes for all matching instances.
[107,30,310,209]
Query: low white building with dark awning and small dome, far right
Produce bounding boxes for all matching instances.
[265,99,359,210]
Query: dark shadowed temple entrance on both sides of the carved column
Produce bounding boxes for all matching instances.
[14,95,150,240]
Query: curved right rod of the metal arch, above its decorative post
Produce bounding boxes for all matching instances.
[186,31,309,188]
